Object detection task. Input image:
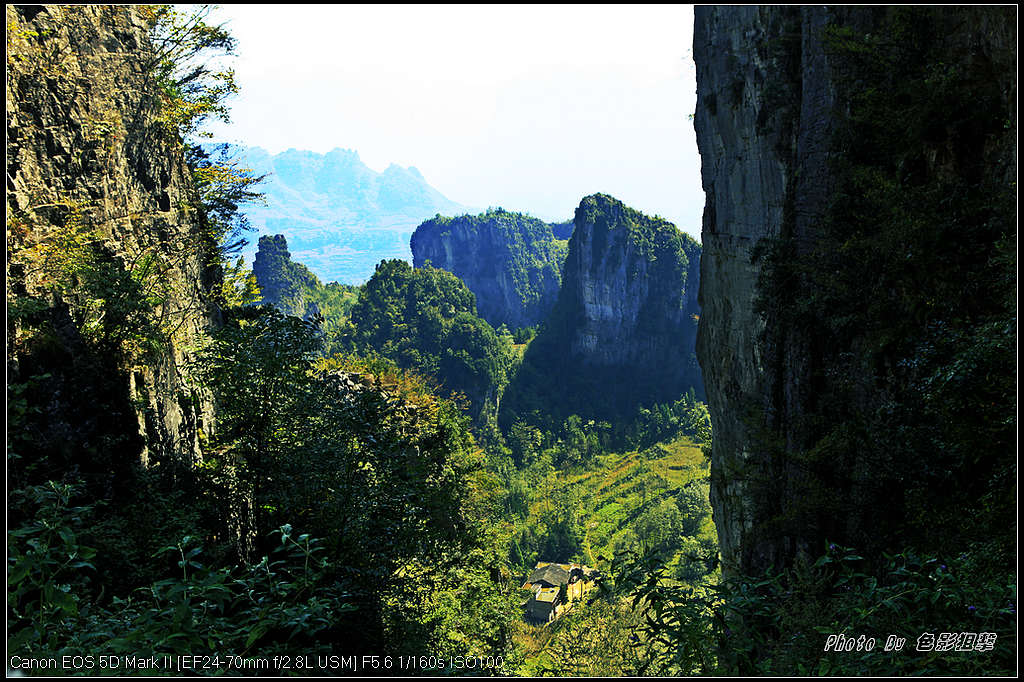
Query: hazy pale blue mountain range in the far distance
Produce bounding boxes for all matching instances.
[224,146,476,284]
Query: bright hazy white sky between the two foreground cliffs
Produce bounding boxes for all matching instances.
[204,5,703,237]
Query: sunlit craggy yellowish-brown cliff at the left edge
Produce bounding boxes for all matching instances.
[7,5,218,476]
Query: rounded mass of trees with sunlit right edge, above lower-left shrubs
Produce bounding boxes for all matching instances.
[191,307,509,654]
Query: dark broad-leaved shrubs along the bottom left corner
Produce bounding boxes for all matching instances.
[7,482,352,659]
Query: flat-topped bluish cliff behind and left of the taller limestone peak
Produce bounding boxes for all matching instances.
[410,210,565,329]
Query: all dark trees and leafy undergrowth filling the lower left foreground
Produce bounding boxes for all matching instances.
[8,307,513,656]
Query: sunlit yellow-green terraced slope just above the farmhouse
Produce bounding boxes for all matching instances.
[506,436,715,580]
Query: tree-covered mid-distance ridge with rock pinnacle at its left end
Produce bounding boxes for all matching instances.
[246,235,514,418]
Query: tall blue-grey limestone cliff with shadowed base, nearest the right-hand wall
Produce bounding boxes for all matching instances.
[503,195,703,423]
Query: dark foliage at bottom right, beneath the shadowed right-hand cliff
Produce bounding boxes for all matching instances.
[616,543,1017,677]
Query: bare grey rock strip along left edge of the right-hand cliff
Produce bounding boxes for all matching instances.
[693,7,811,567]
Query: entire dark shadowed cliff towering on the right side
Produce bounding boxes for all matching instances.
[693,7,1017,571]
